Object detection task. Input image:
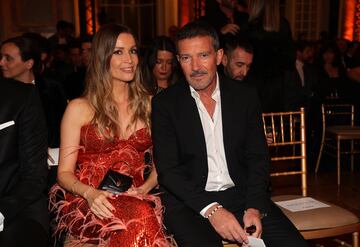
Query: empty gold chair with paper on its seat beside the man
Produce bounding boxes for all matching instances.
[263,108,360,247]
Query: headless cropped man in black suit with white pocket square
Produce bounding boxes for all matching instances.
[0,78,49,247]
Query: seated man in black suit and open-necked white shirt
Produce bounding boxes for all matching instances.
[152,22,307,247]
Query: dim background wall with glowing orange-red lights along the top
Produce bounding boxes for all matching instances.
[0,0,360,43]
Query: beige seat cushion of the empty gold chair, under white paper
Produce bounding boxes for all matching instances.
[272,195,359,231]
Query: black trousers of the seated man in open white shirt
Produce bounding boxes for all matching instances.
[163,188,309,247]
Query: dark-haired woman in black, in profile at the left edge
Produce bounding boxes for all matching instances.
[0,36,67,147]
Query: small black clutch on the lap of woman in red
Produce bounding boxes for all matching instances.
[99,169,132,194]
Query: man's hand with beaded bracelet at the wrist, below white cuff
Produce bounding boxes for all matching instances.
[205,205,249,243]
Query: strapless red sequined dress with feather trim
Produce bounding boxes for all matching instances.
[50,125,172,247]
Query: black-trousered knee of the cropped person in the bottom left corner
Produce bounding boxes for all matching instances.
[0,217,49,247]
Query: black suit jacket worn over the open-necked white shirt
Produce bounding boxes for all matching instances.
[152,76,270,212]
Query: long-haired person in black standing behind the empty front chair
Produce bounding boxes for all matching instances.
[239,0,296,112]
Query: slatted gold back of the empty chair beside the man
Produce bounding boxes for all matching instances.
[262,108,307,196]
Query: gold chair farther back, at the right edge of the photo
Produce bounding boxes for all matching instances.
[315,104,360,185]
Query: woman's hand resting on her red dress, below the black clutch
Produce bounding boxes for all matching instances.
[84,188,115,219]
